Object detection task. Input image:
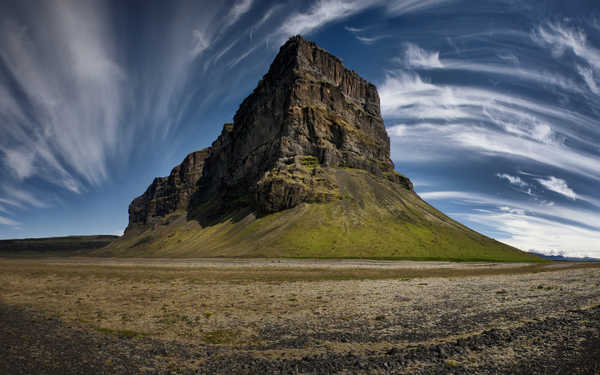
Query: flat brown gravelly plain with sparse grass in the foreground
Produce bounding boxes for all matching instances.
[0,258,600,374]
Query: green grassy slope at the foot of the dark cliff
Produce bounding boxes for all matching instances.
[99,169,543,261]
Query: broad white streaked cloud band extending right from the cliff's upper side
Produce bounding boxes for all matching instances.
[379,71,600,180]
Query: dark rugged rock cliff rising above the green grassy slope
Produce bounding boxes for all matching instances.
[129,36,412,232]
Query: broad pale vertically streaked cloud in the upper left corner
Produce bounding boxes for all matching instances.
[0,2,127,191]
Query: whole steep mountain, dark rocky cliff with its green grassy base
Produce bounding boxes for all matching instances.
[103,36,540,261]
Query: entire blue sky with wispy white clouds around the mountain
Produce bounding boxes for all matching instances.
[0,0,600,257]
